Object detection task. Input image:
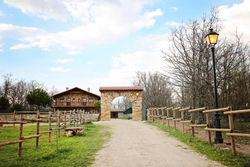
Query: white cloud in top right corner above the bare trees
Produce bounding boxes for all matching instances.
[218,0,250,42]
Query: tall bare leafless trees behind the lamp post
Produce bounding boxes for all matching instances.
[163,13,250,108]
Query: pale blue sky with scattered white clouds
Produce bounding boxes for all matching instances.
[0,0,250,94]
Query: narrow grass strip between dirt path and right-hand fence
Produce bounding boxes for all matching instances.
[146,121,250,167]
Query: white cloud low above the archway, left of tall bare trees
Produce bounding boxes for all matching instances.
[93,34,169,86]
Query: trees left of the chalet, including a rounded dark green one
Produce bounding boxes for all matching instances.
[0,74,52,112]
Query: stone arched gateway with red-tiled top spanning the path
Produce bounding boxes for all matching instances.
[99,86,143,121]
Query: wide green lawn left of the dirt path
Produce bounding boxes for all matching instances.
[0,124,110,167]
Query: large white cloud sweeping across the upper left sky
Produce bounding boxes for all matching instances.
[4,0,162,54]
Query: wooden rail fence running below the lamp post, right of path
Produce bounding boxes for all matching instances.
[147,106,250,155]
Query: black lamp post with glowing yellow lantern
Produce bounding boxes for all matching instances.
[206,28,223,144]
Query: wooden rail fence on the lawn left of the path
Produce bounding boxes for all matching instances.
[0,110,89,157]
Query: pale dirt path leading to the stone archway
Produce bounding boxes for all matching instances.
[93,120,226,167]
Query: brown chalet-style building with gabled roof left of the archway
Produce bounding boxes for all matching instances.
[52,87,101,113]
